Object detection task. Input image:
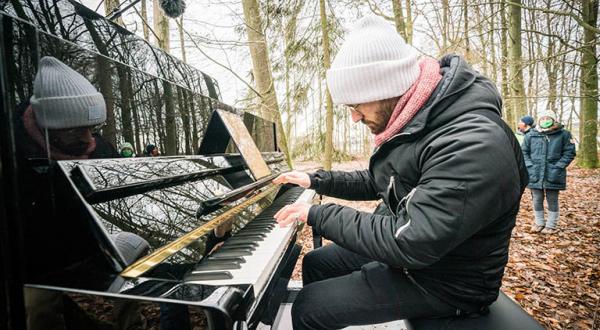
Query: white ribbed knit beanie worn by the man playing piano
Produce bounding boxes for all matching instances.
[327,16,420,104]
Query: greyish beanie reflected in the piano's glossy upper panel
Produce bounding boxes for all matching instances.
[30,56,106,129]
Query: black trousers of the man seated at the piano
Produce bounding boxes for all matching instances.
[292,244,456,330]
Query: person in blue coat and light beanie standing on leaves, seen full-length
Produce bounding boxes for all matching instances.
[522,112,575,234]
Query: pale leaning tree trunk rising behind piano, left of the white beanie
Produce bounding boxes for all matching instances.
[242,0,292,167]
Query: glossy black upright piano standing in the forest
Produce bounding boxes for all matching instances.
[0,0,314,329]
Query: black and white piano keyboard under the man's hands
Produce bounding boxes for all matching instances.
[184,187,315,297]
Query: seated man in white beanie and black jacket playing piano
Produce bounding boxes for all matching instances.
[275,17,527,329]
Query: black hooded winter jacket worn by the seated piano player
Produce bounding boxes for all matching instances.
[308,56,527,311]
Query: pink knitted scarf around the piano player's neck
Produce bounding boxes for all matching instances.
[375,57,442,147]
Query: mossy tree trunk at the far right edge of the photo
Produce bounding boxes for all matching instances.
[578,0,598,168]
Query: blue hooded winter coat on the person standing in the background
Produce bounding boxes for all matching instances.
[521,124,575,190]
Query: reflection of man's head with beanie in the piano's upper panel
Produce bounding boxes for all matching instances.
[18,56,117,160]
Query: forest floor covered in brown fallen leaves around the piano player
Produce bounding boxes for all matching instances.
[293,160,600,329]
